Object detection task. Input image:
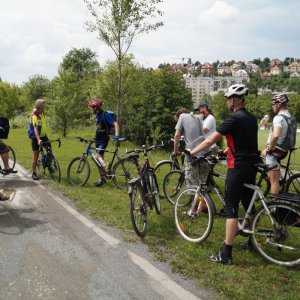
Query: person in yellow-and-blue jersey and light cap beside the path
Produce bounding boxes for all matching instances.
[28,99,50,180]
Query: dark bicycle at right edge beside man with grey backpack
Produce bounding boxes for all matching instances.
[257,148,300,195]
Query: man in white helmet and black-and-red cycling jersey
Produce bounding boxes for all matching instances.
[191,84,260,264]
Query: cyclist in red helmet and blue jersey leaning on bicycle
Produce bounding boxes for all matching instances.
[88,99,119,187]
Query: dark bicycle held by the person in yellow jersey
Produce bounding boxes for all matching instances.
[36,138,61,183]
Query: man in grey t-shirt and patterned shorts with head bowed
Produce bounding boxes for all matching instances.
[173,107,209,215]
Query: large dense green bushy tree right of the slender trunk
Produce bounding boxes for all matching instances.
[126,67,192,144]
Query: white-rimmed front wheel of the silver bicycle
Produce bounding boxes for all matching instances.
[174,188,214,243]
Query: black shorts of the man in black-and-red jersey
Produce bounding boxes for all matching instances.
[225,167,257,218]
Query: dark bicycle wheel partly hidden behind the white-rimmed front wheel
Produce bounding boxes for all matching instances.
[163,170,186,205]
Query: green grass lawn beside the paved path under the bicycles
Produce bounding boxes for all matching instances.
[7,128,300,299]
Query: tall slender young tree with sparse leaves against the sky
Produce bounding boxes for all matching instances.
[84,0,163,123]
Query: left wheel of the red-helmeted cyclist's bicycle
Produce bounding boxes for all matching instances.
[67,156,91,186]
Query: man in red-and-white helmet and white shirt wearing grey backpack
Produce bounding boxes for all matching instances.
[263,94,291,195]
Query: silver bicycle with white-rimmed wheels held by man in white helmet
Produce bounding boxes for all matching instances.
[174,156,300,267]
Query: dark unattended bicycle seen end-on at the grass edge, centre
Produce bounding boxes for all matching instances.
[126,144,163,238]
